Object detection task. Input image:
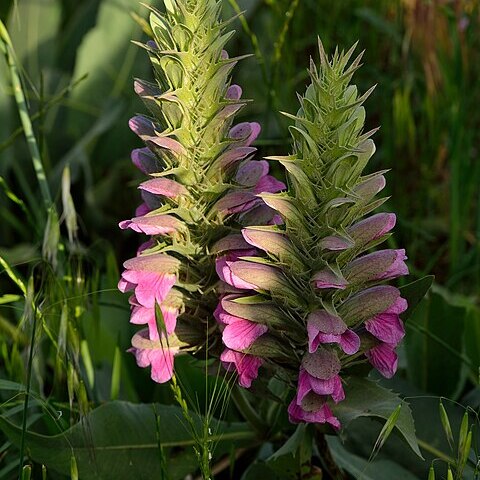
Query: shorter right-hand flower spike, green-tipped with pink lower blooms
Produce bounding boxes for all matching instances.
[216,43,408,428]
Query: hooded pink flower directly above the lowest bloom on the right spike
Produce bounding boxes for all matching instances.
[307,310,360,355]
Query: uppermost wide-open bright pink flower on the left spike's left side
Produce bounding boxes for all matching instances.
[118,253,180,308]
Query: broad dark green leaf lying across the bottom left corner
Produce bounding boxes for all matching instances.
[0,402,253,480]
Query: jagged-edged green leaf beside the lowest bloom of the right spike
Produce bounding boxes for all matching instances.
[333,377,423,458]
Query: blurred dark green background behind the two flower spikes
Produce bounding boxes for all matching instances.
[0,0,480,478]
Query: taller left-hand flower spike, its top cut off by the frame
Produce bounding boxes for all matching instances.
[119,0,285,382]
